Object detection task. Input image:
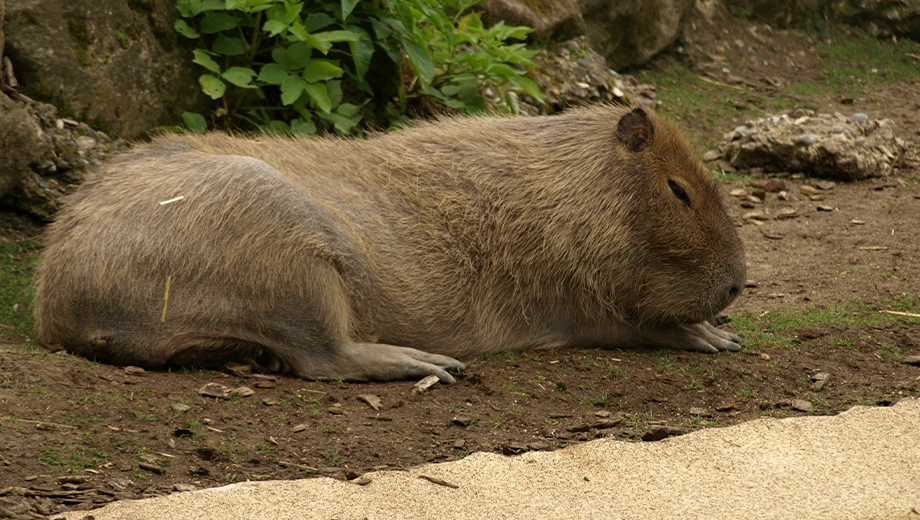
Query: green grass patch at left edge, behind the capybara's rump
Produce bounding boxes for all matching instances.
[0,238,41,339]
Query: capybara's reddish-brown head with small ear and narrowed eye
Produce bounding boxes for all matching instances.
[616,108,745,323]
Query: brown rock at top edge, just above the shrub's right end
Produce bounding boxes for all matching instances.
[476,0,585,40]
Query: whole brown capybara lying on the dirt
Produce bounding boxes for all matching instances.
[36,106,745,382]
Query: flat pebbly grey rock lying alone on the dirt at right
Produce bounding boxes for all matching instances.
[707,110,908,181]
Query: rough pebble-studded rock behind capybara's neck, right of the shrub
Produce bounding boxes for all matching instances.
[522,37,660,115]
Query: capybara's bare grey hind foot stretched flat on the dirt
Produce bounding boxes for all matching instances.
[300,343,466,383]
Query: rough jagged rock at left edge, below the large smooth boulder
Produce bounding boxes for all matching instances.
[0,94,127,219]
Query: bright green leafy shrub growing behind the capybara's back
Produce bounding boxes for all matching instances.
[175,0,541,134]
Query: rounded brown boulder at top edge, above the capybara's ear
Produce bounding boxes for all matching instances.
[578,0,694,70]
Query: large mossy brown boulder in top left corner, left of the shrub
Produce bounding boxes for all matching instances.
[0,0,200,138]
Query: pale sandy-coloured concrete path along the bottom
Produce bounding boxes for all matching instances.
[67,400,920,520]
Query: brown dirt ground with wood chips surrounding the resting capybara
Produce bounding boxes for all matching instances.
[0,9,920,518]
